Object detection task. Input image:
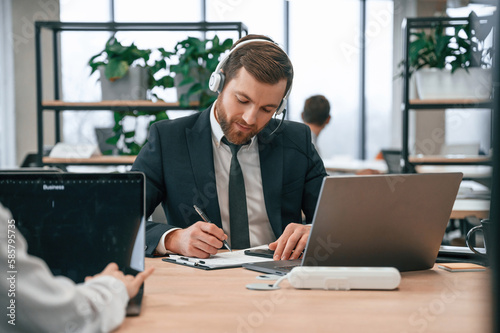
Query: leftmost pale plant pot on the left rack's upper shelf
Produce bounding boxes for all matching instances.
[99,66,148,101]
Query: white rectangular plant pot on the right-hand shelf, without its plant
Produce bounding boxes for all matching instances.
[415,68,492,100]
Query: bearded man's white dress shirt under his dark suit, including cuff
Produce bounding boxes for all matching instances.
[156,103,276,254]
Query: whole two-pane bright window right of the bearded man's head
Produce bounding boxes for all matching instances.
[290,0,393,158]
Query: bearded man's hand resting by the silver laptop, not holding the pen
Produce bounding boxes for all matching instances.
[269,223,311,260]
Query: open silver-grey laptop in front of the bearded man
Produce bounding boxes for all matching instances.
[244,173,462,275]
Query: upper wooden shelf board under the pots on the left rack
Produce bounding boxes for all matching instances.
[42,100,199,112]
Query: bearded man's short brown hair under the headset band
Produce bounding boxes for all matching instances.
[222,35,293,97]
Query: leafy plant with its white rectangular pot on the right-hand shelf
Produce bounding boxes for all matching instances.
[400,12,492,99]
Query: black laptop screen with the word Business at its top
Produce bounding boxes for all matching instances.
[0,172,145,283]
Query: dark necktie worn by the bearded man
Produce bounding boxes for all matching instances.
[222,137,250,249]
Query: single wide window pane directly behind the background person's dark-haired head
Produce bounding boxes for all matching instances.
[290,0,360,158]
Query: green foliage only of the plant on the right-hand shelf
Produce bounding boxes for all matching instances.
[399,12,492,76]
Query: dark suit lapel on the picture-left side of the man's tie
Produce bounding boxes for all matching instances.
[186,108,222,228]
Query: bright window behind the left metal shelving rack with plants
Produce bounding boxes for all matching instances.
[61,0,202,144]
